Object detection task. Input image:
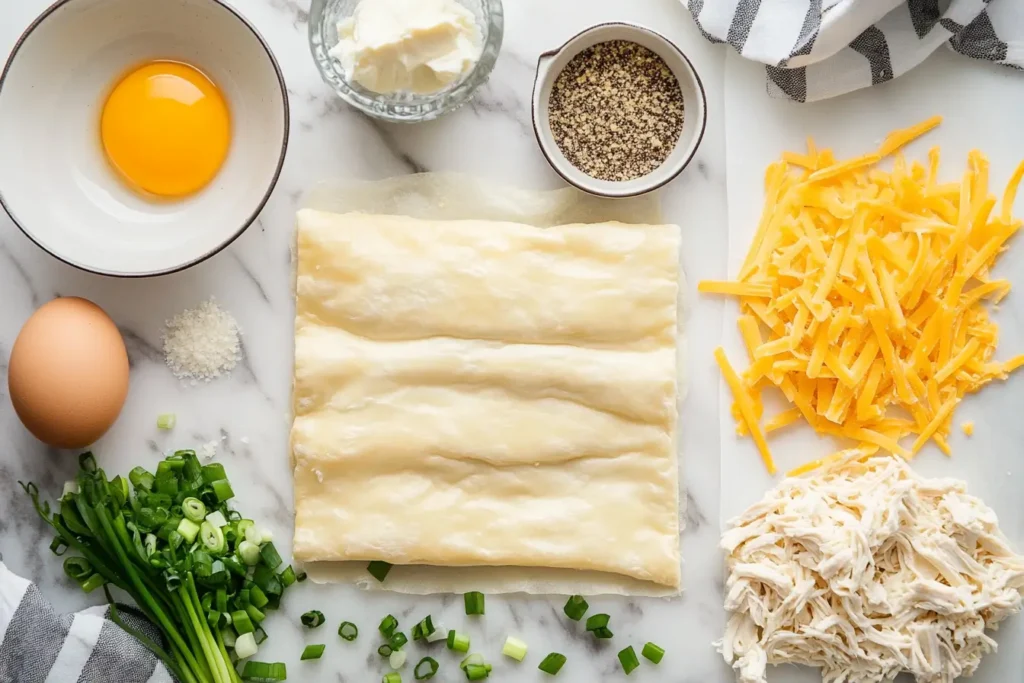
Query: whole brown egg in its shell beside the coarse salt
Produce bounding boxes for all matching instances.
[7,297,128,449]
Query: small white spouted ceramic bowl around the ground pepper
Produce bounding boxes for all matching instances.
[534,23,708,197]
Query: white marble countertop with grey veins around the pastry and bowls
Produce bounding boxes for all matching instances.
[0,0,732,683]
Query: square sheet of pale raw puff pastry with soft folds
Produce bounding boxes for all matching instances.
[291,209,680,589]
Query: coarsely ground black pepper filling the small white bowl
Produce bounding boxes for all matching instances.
[548,40,683,181]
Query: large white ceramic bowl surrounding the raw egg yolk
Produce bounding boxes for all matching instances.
[0,0,289,276]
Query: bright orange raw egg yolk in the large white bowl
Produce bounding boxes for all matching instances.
[99,61,231,198]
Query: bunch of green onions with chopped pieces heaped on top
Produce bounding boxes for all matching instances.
[22,451,301,683]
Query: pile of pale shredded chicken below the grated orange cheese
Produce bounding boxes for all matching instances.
[716,451,1024,683]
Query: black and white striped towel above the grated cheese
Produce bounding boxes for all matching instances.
[683,0,1024,102]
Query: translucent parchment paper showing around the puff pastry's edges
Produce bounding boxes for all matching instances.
[293,173,686,596]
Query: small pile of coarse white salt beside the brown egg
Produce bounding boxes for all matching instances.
[164,298,242,384]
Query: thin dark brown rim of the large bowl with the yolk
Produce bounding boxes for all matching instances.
[0,0,291,279]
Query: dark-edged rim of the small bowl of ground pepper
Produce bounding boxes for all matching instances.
[530,22,708,199]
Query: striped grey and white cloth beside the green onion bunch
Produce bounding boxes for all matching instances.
[0,562,167,683]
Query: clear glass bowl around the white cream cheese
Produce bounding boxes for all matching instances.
[309,0,505,123]
